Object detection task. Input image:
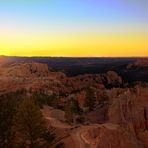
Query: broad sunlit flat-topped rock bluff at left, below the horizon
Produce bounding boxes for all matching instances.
[0,62,65,94]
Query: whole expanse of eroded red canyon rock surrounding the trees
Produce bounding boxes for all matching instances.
[0,60,148,148]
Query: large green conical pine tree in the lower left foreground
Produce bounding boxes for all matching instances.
[13,98,44,147]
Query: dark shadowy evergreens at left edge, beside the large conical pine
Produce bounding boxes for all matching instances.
[0,91,24,147]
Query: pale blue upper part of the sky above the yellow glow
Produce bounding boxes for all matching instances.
[0,0,148,31]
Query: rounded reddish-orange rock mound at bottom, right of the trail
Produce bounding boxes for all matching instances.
[81,124,142,148]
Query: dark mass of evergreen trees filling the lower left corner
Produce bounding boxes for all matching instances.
[0,90,55,148]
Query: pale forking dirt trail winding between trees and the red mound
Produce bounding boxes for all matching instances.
[42,106,121,148]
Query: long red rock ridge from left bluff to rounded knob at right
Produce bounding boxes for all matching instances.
[0,62,122,94]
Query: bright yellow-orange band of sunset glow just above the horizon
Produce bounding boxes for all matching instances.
[0,32,148,57]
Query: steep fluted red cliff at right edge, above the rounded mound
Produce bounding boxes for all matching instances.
[108,90,148,134]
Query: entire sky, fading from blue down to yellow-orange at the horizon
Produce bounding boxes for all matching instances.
[0,0,148,57]
